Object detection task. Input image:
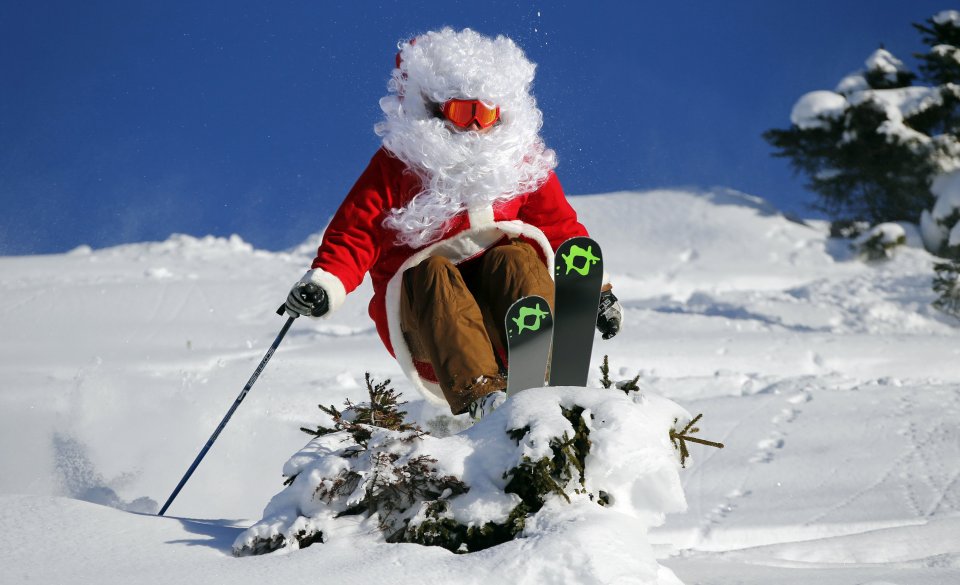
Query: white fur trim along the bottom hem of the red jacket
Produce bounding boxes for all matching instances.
[386,221,553,405]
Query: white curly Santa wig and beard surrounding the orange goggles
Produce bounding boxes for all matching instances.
[375,28,557,248]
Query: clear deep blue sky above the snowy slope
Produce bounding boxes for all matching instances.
[0,0,950,255]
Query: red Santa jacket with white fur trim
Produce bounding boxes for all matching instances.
[311,148,587,404]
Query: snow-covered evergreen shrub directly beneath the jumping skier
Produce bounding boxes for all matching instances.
[233,380,690,558]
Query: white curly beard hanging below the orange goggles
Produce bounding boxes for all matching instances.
[377,97,556,248]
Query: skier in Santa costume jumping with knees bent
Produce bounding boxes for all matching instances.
[285,28,622,419]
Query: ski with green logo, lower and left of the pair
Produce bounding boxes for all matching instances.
[504,295,553,396]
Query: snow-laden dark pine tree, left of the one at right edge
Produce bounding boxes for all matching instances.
[763,48,936,224]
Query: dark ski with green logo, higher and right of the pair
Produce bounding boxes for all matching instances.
[550,237,603,386]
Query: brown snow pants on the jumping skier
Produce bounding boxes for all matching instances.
[400,240,553,414]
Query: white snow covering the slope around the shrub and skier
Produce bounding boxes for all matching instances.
[0,189,960,585]
